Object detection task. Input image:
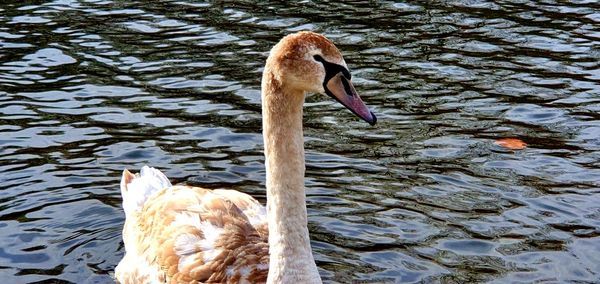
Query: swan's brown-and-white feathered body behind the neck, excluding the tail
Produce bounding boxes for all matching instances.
[115,168,269,283]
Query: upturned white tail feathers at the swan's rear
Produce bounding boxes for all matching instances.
[121,166,171,215]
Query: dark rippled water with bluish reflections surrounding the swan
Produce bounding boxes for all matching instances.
[0,0,600,283]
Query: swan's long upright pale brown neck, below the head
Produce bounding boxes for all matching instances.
[262,66,321,283]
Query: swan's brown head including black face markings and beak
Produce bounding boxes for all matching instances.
[267,32,377,125]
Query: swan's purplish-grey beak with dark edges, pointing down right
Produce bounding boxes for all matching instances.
[325,72,377,125]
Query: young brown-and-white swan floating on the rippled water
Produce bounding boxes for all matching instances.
[115,32,377,284]
